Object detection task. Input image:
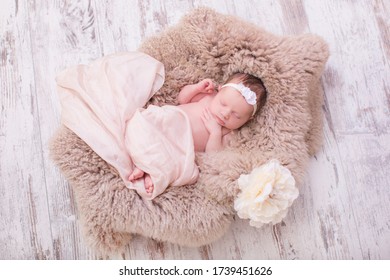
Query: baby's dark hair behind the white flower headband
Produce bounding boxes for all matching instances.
[226,73,267,113]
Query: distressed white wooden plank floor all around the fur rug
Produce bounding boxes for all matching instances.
[0,0,390,259]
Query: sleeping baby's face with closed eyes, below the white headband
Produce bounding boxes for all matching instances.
[209,84,254,129]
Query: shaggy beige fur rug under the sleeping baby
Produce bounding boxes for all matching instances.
[50,8,328,253]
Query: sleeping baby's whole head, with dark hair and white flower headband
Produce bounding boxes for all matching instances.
[210,73,266,129]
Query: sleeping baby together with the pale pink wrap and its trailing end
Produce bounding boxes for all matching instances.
[56,52,265,200]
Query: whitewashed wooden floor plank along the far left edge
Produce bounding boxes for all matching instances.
[0,2,53,259]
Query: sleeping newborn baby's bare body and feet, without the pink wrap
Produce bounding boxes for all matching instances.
[129,73,265,194]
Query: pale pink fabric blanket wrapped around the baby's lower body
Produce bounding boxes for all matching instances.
[56,52,198,199]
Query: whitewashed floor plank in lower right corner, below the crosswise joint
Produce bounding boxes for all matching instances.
[339,134,390,259]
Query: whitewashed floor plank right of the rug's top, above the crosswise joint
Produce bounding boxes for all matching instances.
[307,1,390,133]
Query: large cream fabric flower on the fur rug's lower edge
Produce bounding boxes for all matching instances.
[234,159,299,228]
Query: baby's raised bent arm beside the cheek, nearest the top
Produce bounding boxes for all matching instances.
[177,79,216,104]
